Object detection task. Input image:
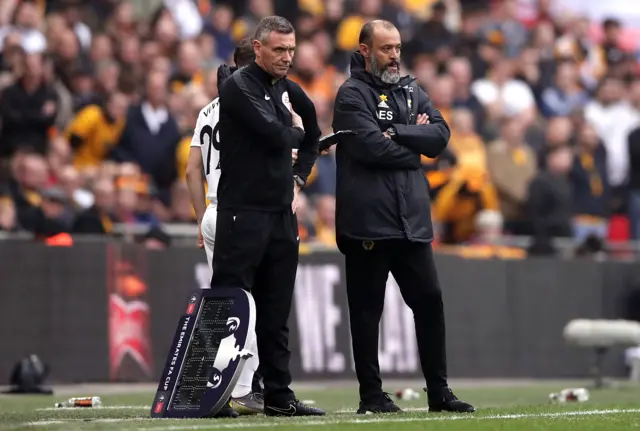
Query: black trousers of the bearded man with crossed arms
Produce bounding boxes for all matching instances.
[339,239,447,401]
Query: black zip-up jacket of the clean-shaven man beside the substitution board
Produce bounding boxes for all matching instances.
[218,62,320,211]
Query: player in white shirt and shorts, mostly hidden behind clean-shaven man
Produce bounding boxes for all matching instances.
[187,39,264,417]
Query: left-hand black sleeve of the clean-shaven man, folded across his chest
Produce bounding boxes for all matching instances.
[220,71,305,149]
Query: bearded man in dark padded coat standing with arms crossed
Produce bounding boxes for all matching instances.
[333,20,475,414]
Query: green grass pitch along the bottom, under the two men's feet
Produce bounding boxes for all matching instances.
[0,382,640,431]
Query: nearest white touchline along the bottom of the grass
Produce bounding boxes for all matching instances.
[112,409,640,431]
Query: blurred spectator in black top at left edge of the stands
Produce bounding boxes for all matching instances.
[0,54,57,157]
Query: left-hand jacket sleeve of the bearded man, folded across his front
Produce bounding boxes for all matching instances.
[333,86,420,169]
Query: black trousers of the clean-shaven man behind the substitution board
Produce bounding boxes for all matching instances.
[211,209,298,404]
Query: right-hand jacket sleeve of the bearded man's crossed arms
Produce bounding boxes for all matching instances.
[393,87,451,158]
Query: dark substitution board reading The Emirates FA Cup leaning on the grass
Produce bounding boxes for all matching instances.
[151,288,256,418]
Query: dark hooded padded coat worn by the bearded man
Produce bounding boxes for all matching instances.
[333,52,450,245]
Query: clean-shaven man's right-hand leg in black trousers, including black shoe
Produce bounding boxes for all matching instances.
[253,210,324,416]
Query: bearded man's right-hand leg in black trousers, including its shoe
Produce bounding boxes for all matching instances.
[391,241,475,413]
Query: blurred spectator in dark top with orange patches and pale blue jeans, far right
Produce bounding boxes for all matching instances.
[570,124,609,241]
